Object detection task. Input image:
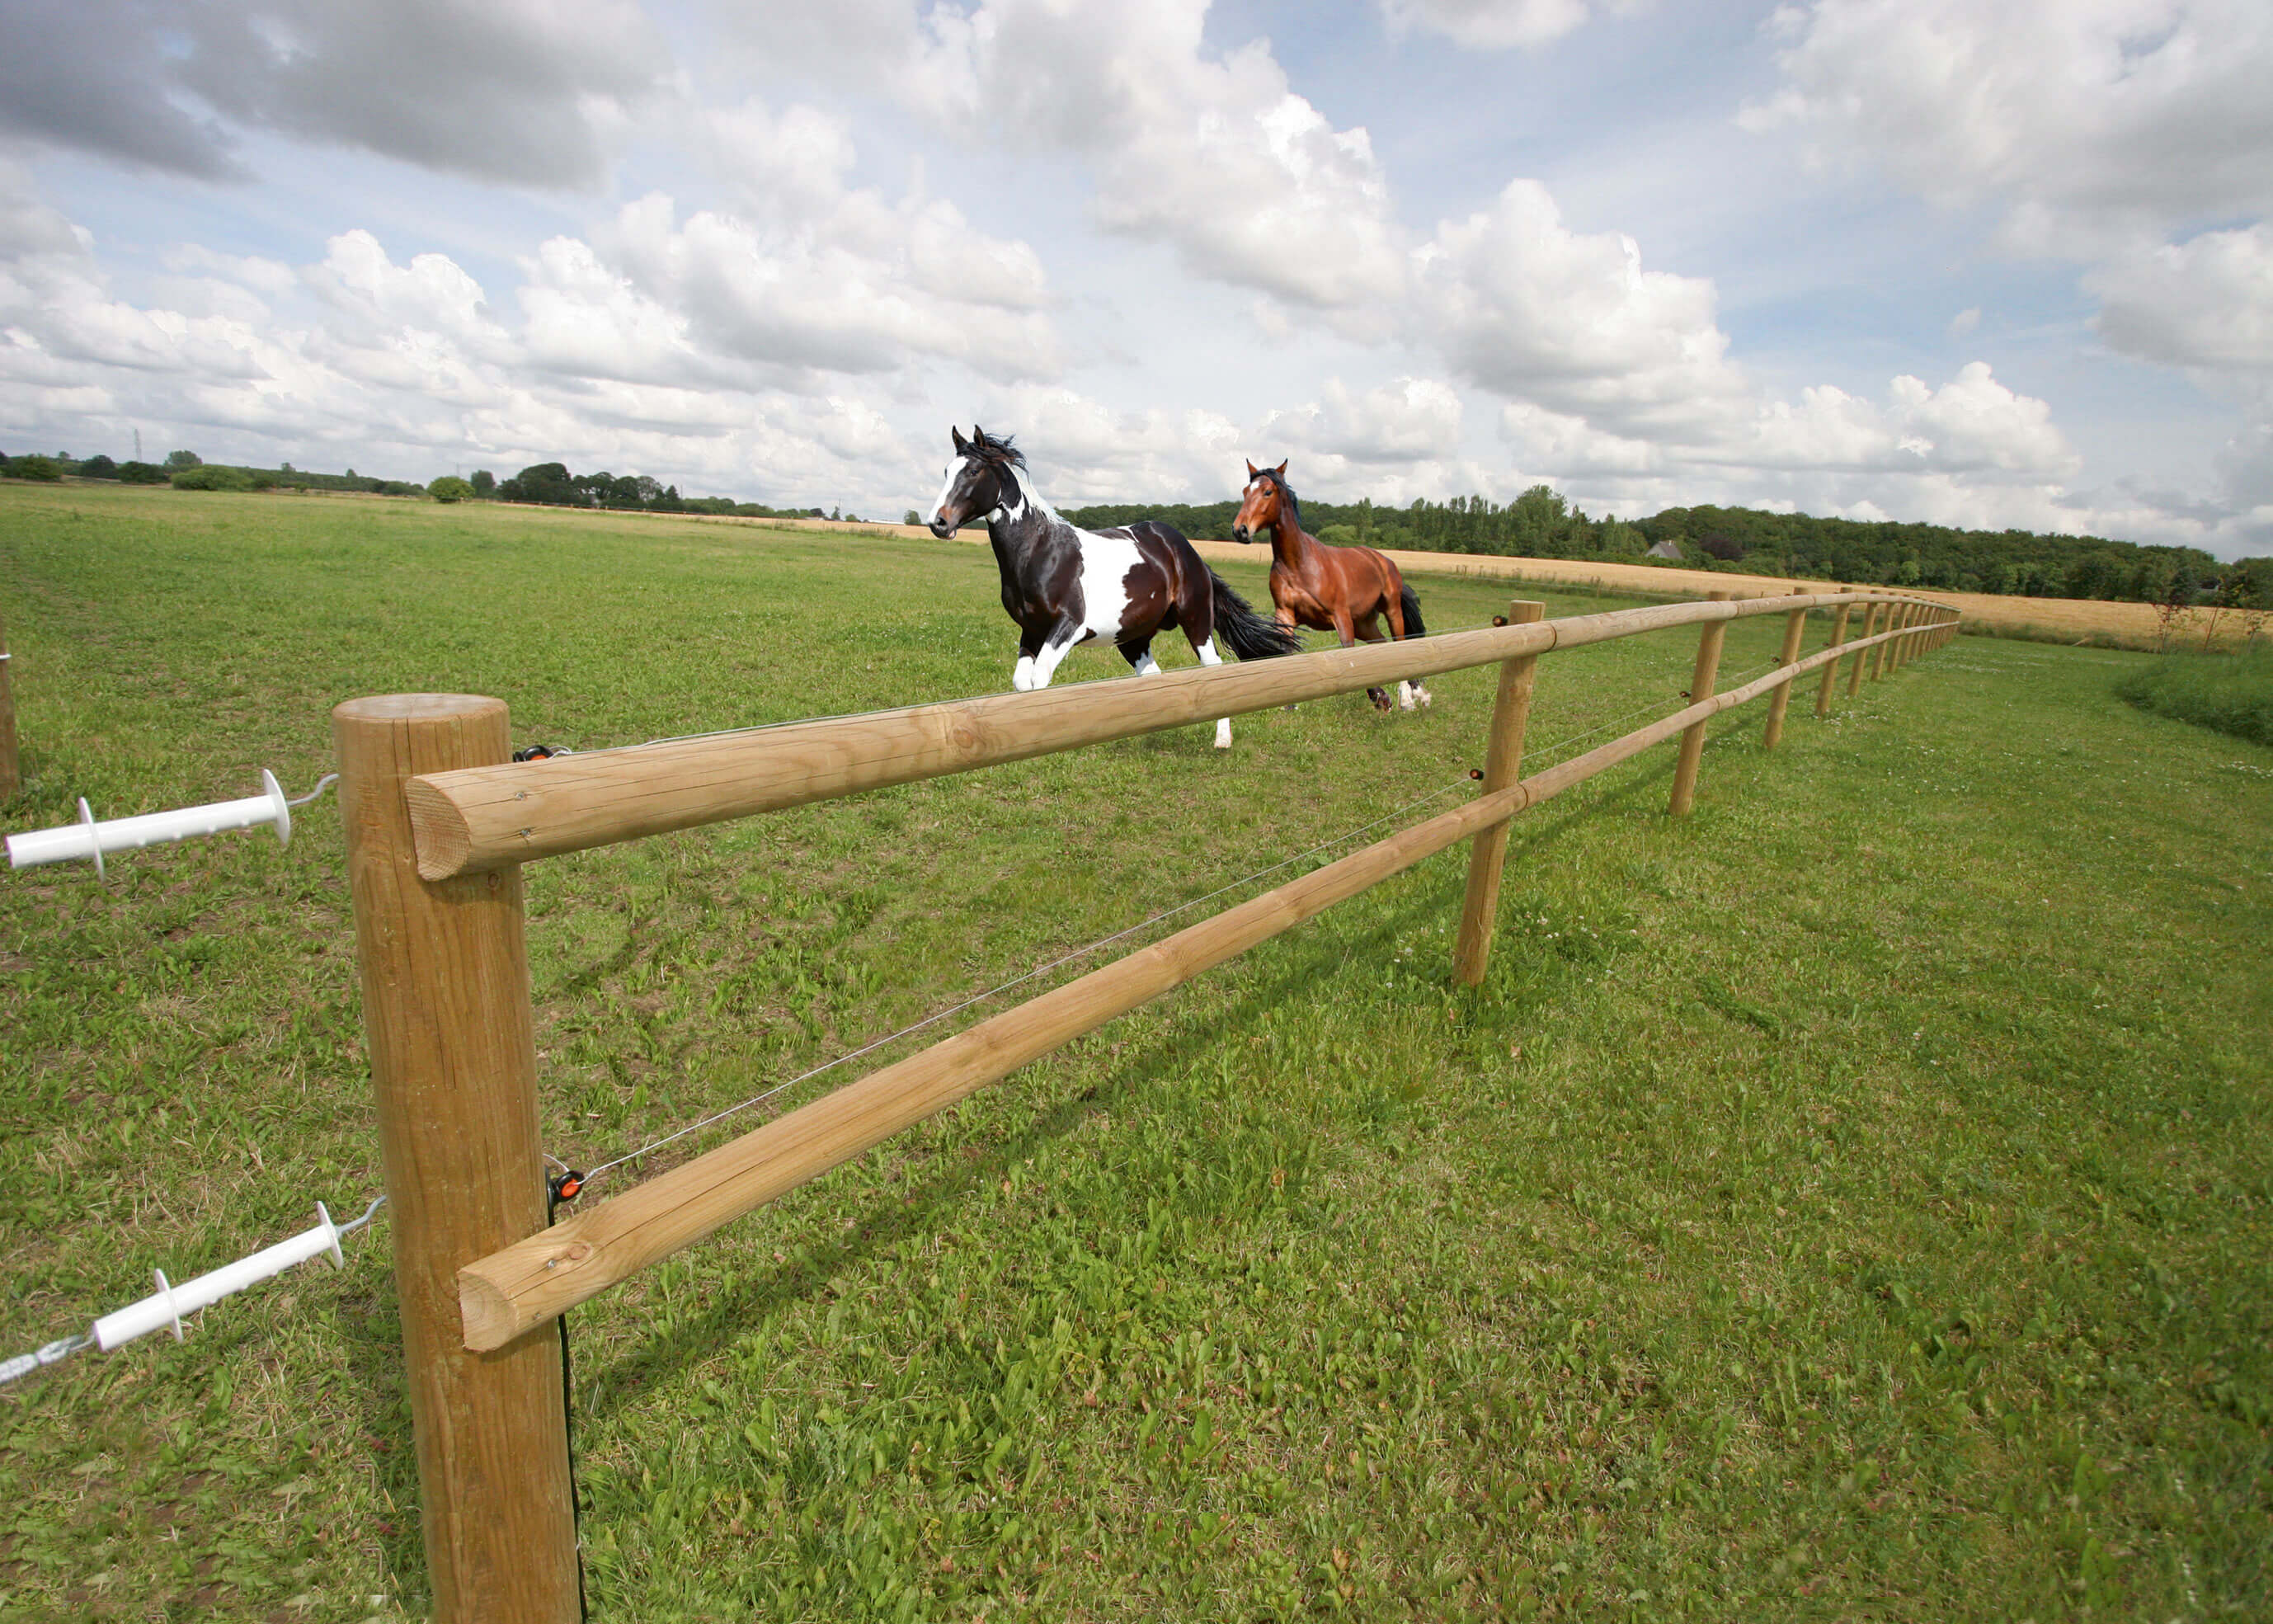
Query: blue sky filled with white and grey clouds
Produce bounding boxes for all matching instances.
[0,0,2273,558]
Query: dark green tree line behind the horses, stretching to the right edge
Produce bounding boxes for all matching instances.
[1066,484,2273,605]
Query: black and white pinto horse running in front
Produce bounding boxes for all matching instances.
[929,426,1302,748]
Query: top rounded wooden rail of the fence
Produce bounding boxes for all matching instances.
[407,594,1881,880]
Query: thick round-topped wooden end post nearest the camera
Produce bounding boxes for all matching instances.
[332,694,577,1624]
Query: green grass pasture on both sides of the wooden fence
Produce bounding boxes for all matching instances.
[0,487,2273,1619]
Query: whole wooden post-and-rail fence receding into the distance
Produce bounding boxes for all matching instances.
[332,577,1957,1624]
